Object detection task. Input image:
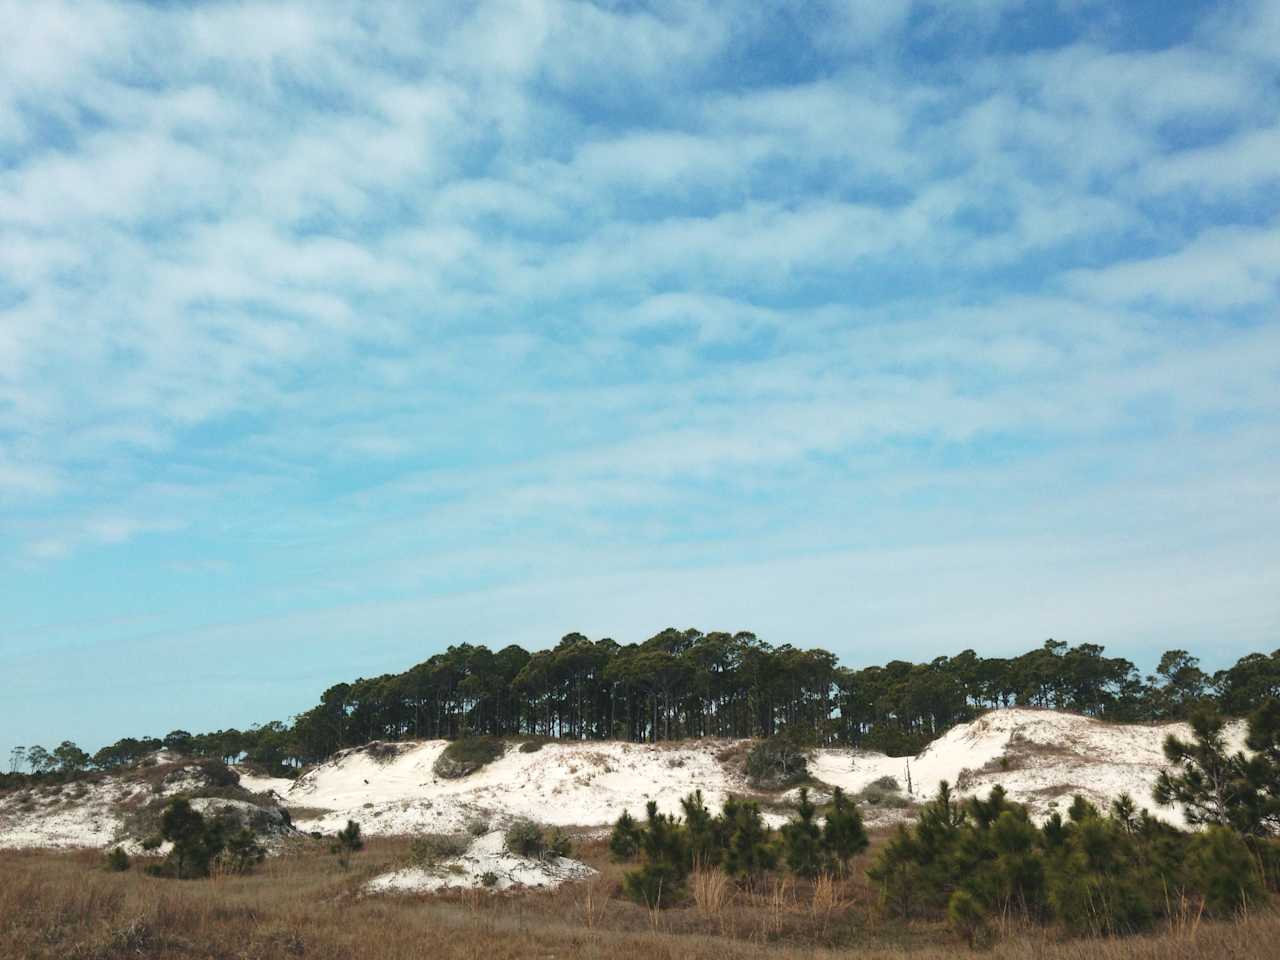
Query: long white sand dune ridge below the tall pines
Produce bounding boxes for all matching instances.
[0,709,1244,847]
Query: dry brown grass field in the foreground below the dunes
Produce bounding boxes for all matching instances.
[0,840,1280,960]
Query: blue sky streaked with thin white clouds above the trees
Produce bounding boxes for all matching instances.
[0,0,1280,751]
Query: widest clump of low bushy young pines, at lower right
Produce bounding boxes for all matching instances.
[868,783,1262,938]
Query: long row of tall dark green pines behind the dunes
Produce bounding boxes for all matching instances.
[10,628,1280,774]
